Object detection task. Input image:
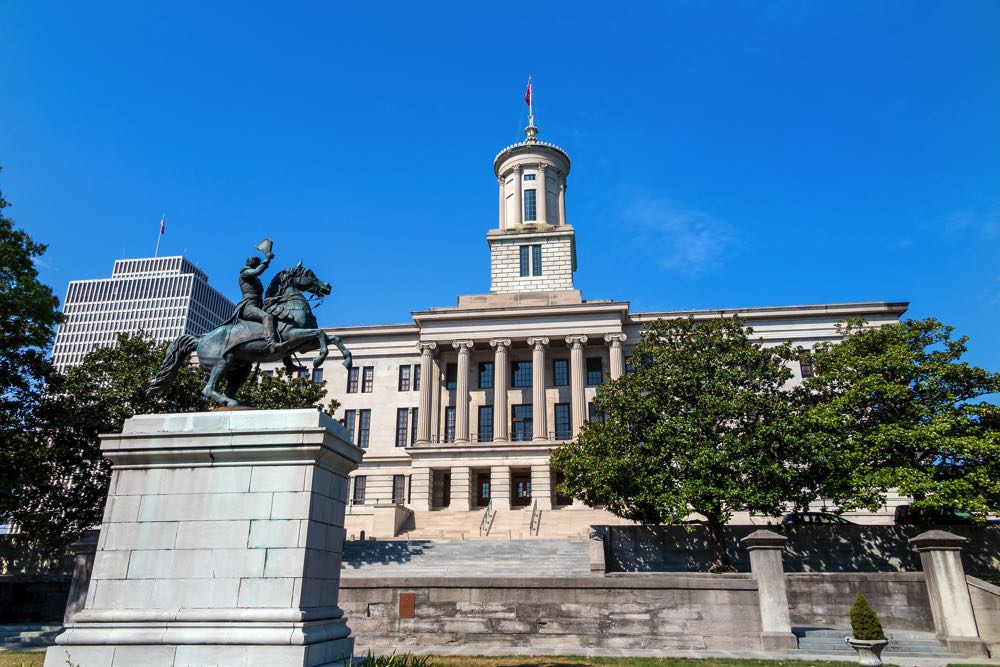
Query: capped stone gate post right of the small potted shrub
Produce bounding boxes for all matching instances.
[910,530,989,657]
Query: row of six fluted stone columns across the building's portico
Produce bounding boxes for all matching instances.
[416,333,625,444]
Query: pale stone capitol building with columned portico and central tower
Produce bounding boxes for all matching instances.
[268,122,908,537]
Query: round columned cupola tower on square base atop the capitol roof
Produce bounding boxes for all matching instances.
[486,116,576,296]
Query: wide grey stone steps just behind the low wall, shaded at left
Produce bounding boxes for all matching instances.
[341,536,590,578]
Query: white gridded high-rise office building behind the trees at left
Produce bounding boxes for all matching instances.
[52,256,236,370]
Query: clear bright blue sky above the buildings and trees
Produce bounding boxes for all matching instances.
[0,0,1000,370]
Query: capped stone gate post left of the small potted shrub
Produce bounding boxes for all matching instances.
[740,530,798,651]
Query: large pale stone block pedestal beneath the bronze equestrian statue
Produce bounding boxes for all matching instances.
[45,410,362,667]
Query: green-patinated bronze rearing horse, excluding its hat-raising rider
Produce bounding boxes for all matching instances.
[147,262,352,405]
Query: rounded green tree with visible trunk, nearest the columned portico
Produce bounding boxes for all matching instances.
[552,318,805,570]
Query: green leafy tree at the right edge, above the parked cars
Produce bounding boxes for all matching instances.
[799,319,1000,520]
